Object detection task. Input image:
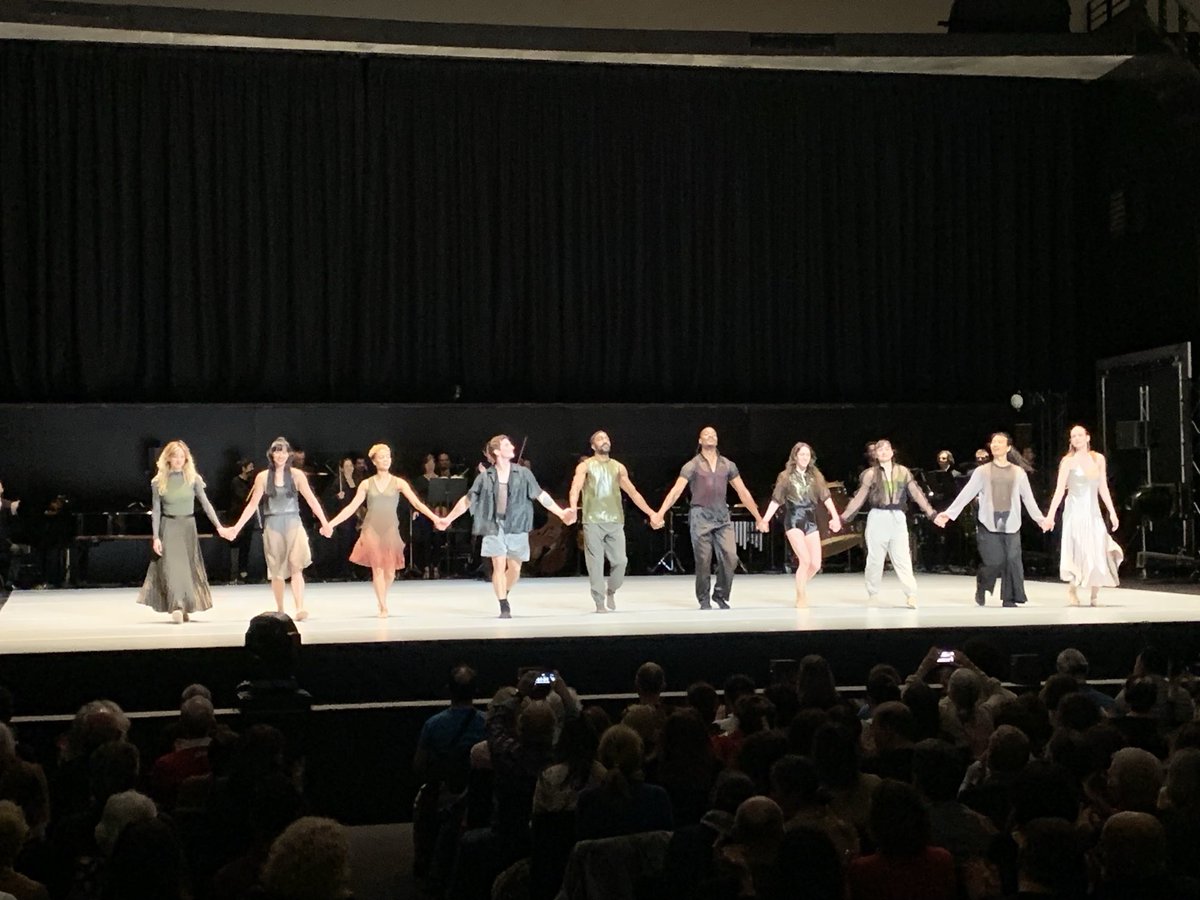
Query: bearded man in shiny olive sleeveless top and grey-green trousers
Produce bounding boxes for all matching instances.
[568,431,654,612]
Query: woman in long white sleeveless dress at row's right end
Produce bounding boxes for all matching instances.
[1045,425,1124,606]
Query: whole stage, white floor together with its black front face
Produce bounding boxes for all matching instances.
[0,574,1200,714]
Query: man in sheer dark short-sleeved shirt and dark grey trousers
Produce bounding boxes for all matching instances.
[650,426,762,610]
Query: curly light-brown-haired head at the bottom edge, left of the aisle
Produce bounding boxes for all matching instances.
[262,816,350,900]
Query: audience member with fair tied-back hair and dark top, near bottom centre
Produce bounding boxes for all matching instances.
[575,725,674,840]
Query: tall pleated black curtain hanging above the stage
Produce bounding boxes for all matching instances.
[0,42,1156,403]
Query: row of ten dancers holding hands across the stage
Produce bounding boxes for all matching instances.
[139,426,1121,622]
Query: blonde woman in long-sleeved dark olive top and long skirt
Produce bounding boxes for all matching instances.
[138,440,228,624]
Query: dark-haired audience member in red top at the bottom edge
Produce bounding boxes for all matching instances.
[847,780,958,900]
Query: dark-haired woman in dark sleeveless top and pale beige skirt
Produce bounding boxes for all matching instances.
[229,438,328,622]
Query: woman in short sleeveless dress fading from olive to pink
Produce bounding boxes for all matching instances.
[320,444,440,619]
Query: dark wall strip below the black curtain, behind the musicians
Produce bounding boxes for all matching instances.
[0,402,1014,514]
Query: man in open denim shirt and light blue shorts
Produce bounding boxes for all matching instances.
[439,434,575,619]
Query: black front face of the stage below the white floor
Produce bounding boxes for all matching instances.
[7,610,1196,716]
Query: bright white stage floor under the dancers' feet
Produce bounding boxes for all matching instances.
[0,574,1200,654]
